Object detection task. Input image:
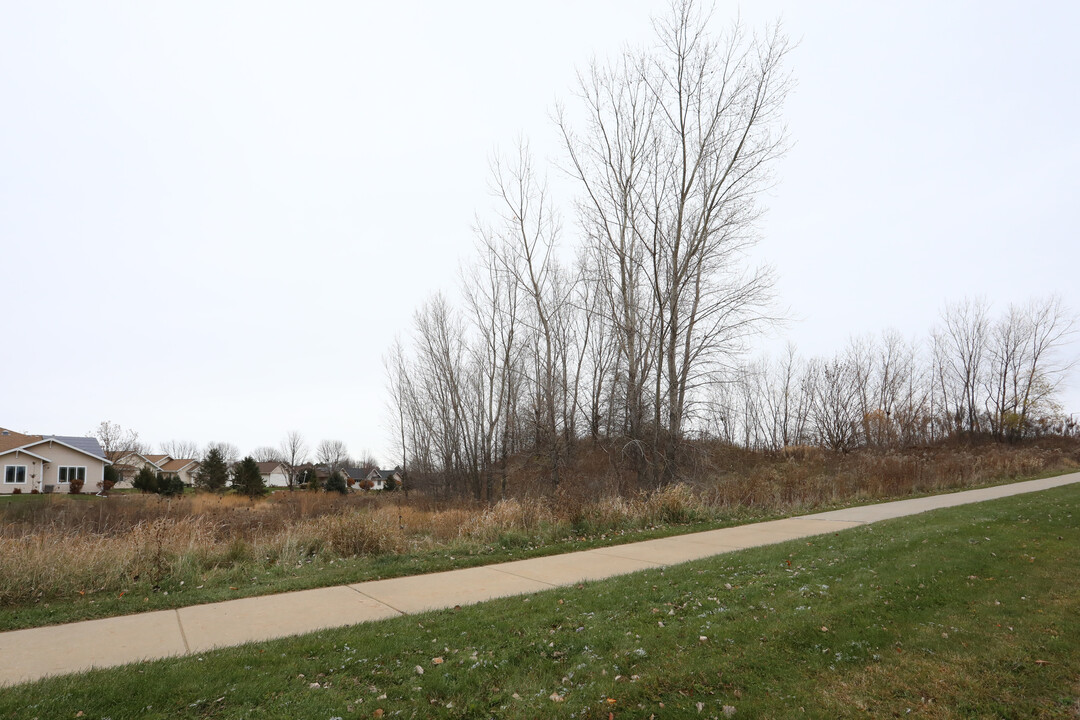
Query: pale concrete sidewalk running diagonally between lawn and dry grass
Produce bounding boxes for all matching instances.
[0,473,1080,687]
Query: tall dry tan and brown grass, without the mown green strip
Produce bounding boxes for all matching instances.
[0,443,1080,607]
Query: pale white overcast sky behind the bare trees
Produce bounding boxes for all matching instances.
[0,0,1080,463]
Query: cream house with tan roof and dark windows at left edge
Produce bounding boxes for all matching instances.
[0,427,112,494]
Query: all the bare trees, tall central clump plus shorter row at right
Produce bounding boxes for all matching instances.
[386,0,1071,500]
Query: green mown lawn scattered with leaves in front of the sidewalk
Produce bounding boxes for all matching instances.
[0,485,1080,720]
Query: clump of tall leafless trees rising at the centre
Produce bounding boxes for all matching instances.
[387,0,789,498]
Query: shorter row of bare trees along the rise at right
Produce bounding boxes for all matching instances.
[710,296,1076,450]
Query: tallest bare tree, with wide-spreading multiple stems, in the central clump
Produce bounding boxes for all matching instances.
[559,0,789,481]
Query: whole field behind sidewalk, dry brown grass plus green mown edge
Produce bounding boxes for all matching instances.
[0,439,1080,630]
